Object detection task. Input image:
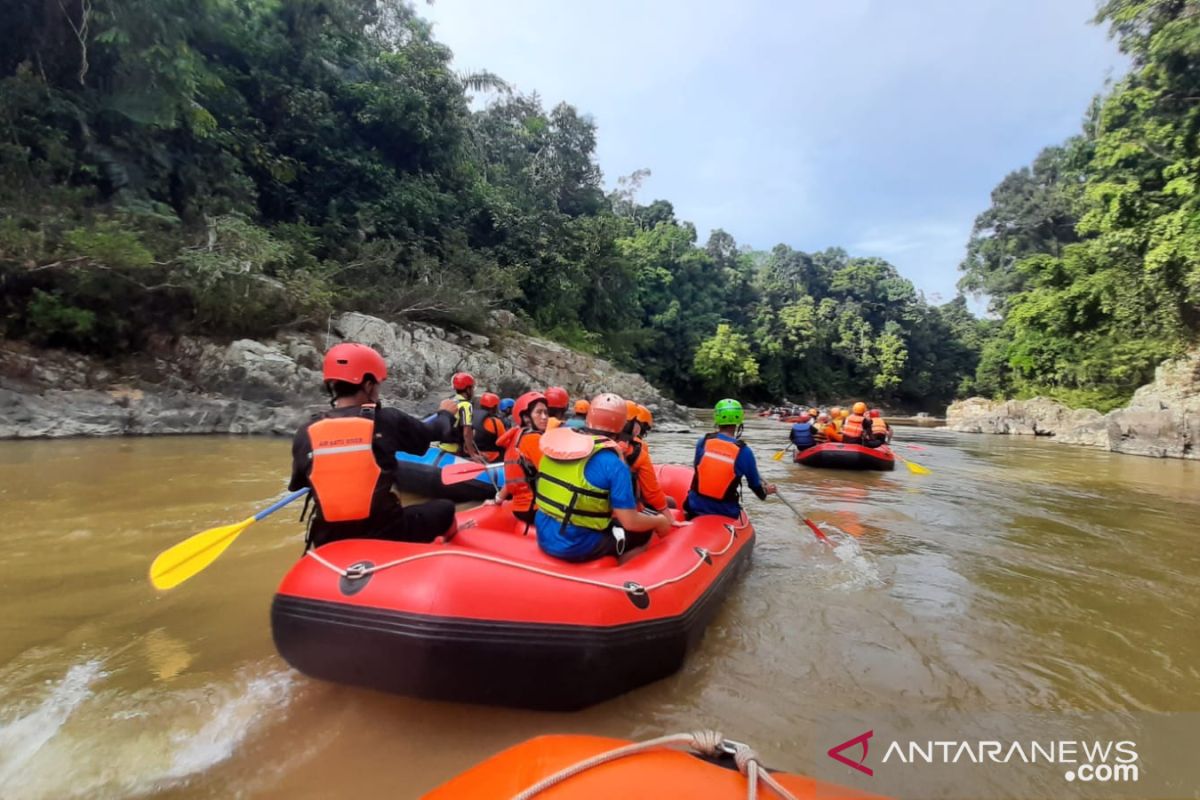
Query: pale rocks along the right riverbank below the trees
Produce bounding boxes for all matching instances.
[946,350,1200,458]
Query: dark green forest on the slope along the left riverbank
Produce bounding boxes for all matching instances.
[0,0,988,405]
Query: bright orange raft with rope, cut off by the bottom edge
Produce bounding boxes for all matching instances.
[424,733,877,800]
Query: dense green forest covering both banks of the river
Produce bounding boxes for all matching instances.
[0,0,1200,409]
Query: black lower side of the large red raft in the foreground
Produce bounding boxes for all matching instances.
[271,534,752,711]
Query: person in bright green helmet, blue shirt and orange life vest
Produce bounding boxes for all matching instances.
[683,398,775,519]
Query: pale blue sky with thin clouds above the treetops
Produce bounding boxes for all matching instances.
[418,0,1124,300]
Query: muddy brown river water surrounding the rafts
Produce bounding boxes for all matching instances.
[0,420,1200,800]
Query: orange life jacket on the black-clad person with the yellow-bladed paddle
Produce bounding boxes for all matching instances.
[308,405,383,522]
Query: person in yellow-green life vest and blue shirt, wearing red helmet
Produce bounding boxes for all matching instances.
[536,392,679,561]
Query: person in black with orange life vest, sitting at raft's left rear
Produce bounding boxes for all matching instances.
[288,342,457,547]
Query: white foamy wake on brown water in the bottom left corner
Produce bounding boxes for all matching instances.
[0,658,295,800]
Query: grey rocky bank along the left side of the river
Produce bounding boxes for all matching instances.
[0,313,690,439]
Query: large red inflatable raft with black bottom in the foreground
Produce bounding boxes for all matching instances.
[271,465,755,710]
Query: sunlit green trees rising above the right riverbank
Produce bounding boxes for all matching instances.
[961,0,1200,409]
